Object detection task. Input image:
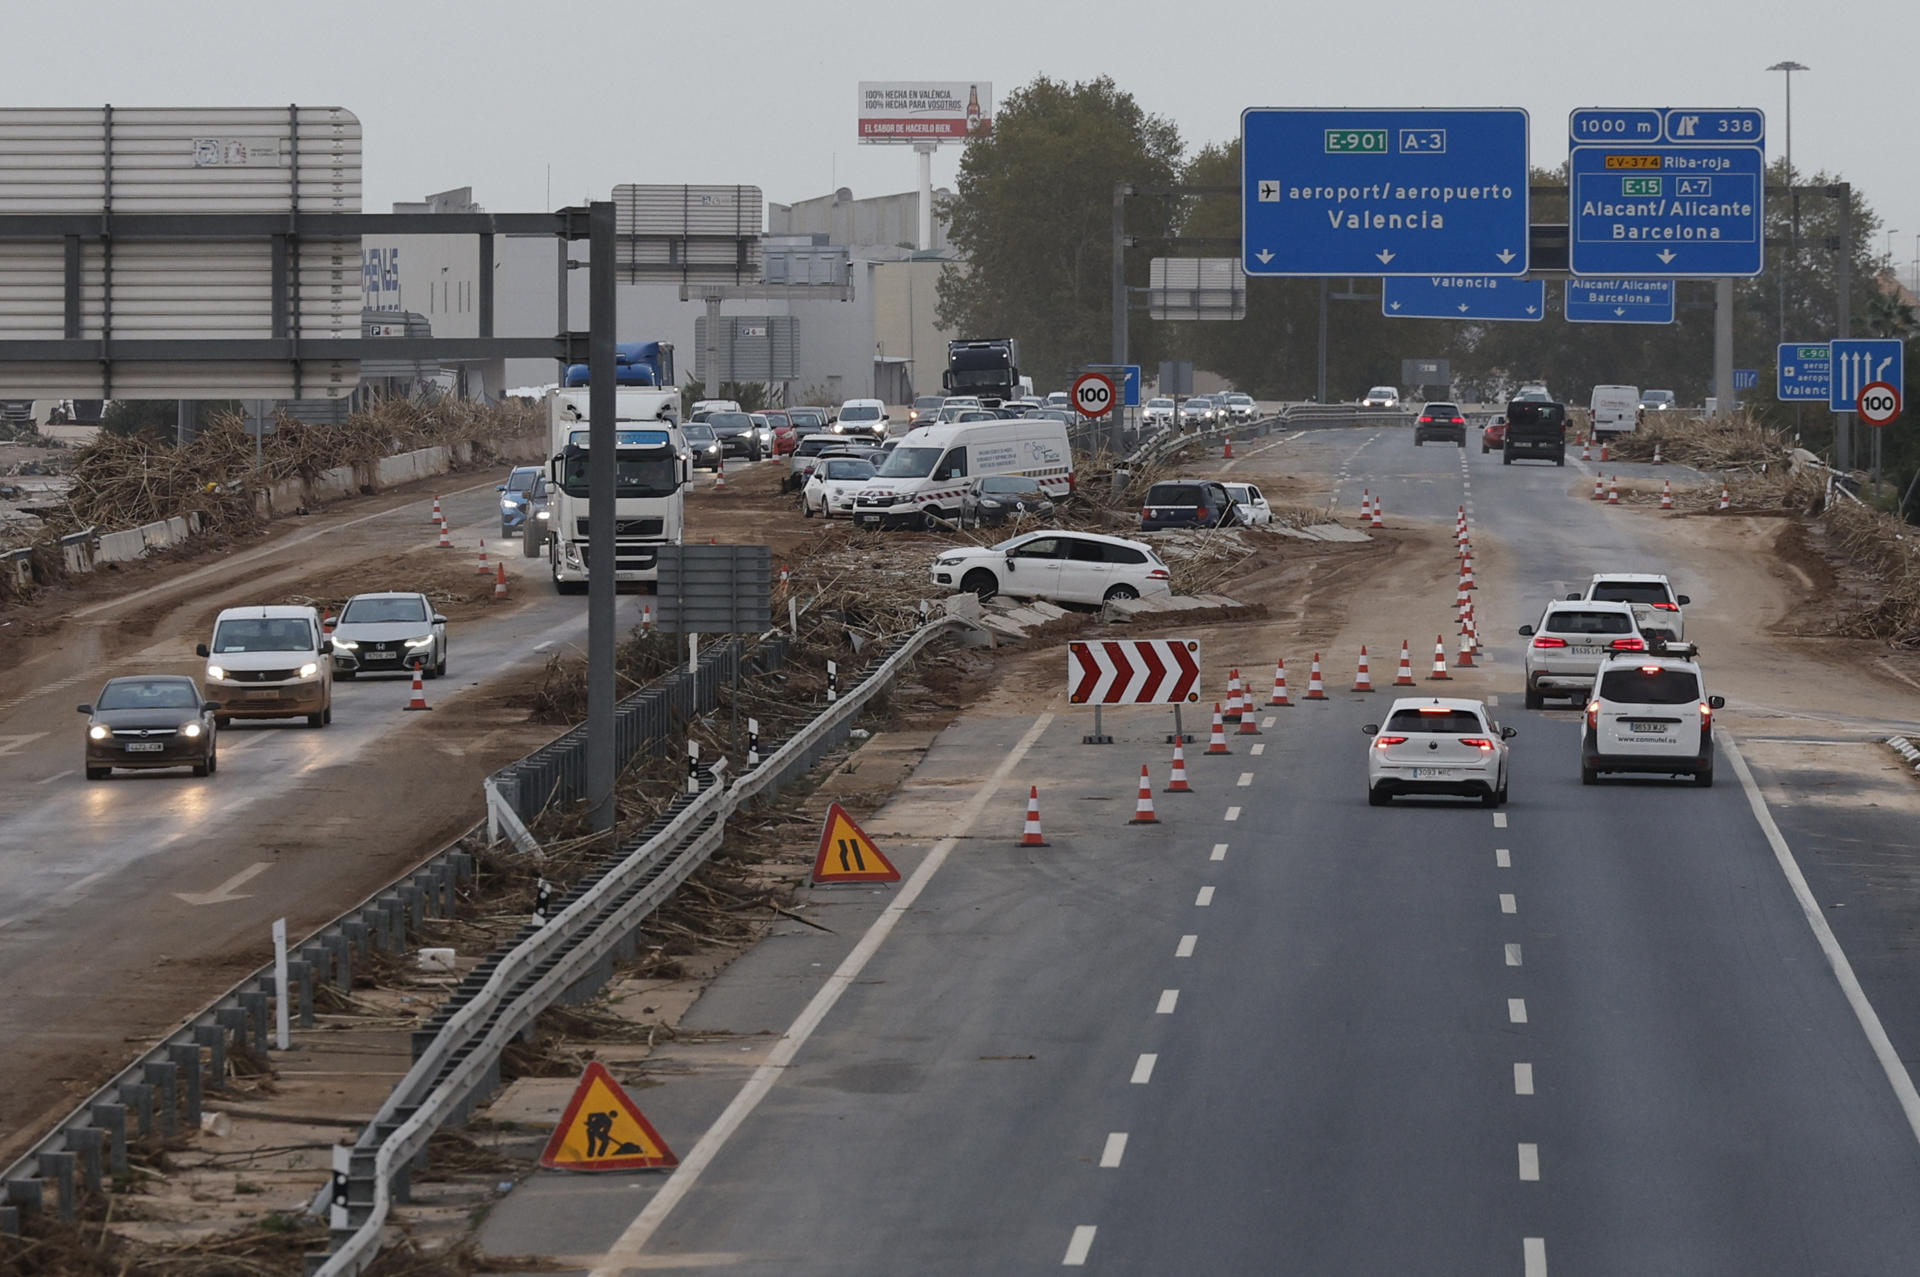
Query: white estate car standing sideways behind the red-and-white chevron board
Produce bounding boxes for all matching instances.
[931,532,1173,603]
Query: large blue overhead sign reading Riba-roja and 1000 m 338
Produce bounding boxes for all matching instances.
[1567,108,1766,277]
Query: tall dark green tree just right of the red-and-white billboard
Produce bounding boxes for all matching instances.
[920,75,1183,386]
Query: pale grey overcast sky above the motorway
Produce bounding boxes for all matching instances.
[15,0,1920,275]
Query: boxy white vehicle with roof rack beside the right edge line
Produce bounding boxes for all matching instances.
[1580,645,1726,787]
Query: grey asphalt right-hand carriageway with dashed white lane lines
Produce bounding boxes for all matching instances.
[482,430,1920,1277]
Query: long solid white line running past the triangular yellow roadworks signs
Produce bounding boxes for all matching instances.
[589,714,1059,1277]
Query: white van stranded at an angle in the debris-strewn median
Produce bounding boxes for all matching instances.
[852,417,1073,528]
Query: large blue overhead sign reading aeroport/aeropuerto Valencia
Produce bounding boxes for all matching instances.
[1240,108,1530,277]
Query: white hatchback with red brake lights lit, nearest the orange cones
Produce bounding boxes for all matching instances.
[1361,697,1515,807]
